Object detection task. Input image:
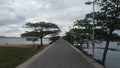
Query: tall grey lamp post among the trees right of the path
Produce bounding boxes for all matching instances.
[85,0,96,58]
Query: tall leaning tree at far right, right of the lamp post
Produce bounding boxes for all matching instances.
[97,0,120,64]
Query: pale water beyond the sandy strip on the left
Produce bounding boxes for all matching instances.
[0,38,50,44]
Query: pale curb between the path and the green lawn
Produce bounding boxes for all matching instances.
[16,42,55,68]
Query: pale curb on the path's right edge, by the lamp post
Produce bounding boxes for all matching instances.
[64,40,104,68]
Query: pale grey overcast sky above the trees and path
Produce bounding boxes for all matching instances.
[0,0,93,37]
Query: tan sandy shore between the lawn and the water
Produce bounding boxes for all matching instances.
[0,44,48,48]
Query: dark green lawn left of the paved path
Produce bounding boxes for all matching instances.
[0,47,43,68]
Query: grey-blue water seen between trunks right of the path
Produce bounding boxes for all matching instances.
[84,41,120,68]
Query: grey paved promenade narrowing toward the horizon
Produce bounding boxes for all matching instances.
[17,39,101,68]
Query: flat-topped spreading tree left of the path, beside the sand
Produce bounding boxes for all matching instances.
[22,22,60,46]
